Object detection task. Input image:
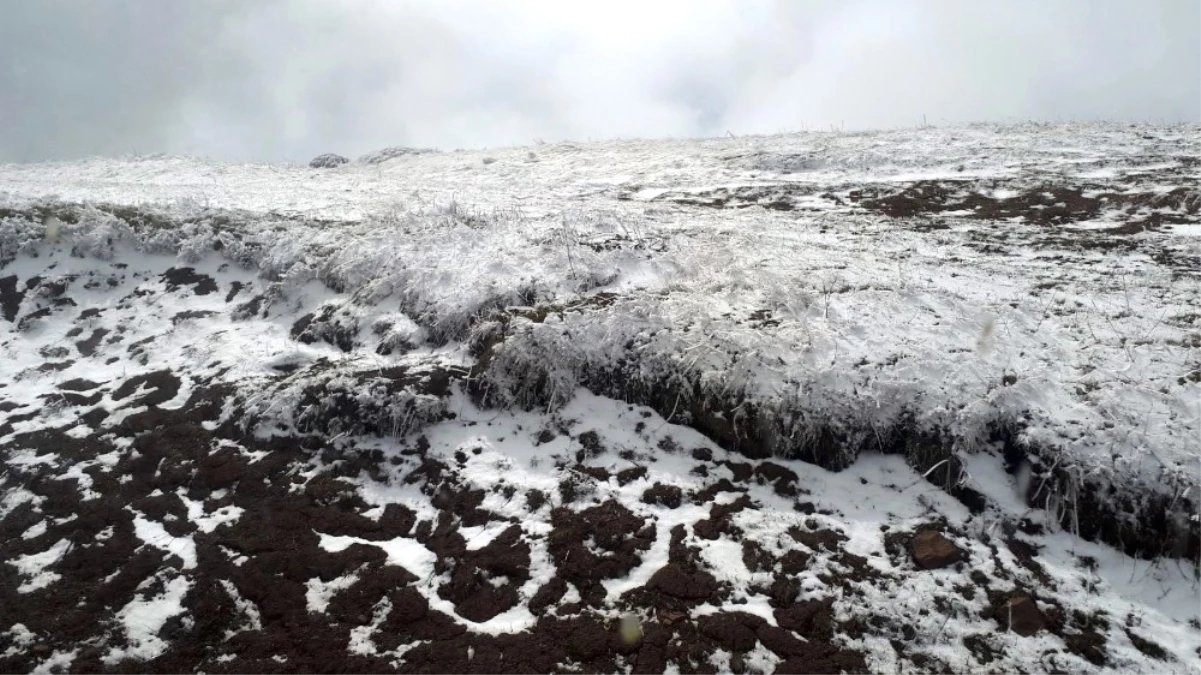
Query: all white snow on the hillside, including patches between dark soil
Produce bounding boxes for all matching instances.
[7,125,1201,671]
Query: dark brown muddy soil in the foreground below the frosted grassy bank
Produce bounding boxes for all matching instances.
[0,372,1167,674]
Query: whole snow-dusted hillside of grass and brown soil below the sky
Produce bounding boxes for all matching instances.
[0,125,1201,673]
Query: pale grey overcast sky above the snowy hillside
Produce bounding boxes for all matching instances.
[0,0,1201,162]
